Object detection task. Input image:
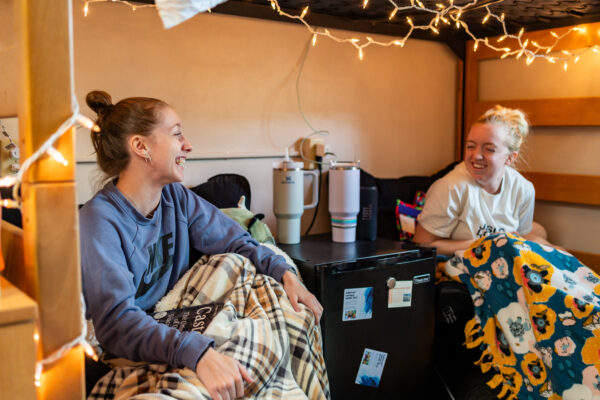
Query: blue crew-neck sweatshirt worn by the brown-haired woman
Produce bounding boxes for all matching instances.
[79,182,290,370]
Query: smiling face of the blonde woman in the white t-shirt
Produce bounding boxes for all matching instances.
[465,124,518,194]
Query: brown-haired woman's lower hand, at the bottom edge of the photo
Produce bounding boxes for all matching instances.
[196,347,253,400]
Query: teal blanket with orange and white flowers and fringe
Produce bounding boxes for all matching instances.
[445,233,600,400]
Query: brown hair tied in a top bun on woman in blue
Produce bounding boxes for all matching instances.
[85,90,168,177]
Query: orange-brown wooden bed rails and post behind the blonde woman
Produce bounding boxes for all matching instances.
[456,23,600,273]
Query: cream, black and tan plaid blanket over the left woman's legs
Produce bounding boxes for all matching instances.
[88,254,330,400]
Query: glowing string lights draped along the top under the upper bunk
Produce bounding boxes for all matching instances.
[83,0,600,67]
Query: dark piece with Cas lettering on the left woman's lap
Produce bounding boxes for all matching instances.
[151,303,223,333]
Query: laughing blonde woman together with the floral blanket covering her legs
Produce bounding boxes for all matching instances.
[415,106,600,399]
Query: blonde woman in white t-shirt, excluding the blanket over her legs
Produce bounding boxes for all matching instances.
[414,106,549,255]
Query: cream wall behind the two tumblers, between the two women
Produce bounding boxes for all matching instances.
[73,1,457,238]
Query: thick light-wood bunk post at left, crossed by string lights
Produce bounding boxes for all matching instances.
[17,0,85,399]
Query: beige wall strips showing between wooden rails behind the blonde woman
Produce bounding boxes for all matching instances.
[479,52,600,253]
